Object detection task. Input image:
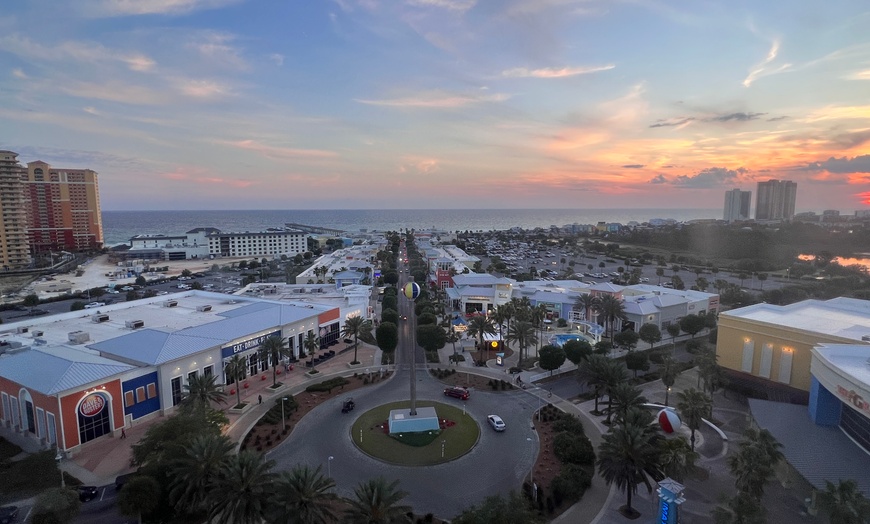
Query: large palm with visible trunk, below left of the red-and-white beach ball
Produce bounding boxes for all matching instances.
[597,425,656,516]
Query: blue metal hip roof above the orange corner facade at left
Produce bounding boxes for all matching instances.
[0,348,133,395]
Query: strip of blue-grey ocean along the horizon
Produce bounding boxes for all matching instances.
[103,209,722,246]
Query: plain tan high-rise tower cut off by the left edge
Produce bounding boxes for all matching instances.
[0,151,30,270]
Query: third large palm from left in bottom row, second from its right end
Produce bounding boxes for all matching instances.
[267,465,339,524]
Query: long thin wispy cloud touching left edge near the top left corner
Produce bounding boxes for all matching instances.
[0,34,156,71]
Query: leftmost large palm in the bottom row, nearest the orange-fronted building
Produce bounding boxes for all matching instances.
[169,435,235,513]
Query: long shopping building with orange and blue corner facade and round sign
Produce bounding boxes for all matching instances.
[0,291,348,453]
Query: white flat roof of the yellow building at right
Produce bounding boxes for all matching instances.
[721,297,870,341]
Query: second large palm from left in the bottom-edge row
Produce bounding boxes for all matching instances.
[208,450,275,524]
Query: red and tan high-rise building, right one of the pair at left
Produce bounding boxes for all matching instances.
[22,161,103,253]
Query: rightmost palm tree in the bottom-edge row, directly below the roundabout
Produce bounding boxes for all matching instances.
[345,477,411,524]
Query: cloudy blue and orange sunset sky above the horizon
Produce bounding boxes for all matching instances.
[0,0,870,213]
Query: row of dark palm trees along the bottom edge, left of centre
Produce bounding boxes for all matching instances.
[119,434,411,524]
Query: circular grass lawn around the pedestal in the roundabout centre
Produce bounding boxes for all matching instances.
[350,401,480,466]
